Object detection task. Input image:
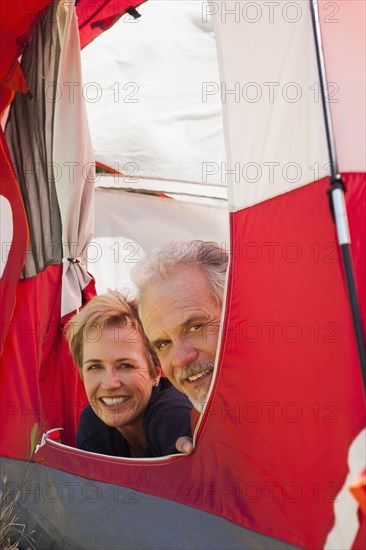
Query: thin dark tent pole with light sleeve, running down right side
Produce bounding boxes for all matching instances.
[309,0,366,393]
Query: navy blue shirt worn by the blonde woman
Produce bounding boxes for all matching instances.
[76,378,192,457]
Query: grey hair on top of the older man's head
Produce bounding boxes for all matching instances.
[132,241,229,305]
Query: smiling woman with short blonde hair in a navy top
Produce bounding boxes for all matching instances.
[67,291,191,458]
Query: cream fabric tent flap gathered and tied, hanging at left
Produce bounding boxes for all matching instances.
[52,0,95,316]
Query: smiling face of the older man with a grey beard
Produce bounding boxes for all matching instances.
[141,266,221,411]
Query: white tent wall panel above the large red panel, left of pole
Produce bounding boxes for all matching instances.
[211,1,329,211]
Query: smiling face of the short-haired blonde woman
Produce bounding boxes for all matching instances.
[82,325,160,433]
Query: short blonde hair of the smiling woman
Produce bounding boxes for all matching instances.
[65,290,160,377]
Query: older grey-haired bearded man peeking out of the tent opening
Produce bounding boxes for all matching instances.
[133,241,228,453]
